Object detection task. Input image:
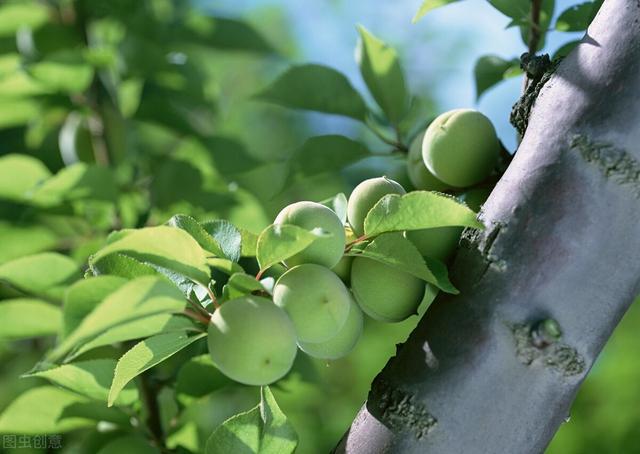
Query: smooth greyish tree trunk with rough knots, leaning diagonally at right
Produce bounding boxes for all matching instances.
[336,0,640,454]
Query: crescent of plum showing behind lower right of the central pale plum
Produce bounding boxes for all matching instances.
[300,299,364,359]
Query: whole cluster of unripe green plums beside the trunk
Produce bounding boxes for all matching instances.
[209,110,499,385]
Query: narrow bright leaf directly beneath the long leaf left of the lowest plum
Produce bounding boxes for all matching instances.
[67,314,196,361]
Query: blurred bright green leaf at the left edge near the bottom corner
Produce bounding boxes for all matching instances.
[0,386,96,435]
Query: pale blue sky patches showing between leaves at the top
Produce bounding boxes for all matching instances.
[211,0,580,152]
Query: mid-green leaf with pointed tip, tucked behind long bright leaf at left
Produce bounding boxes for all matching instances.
[61,276,127,338]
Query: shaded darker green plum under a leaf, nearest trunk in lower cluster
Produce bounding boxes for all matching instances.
[351,257,425,323]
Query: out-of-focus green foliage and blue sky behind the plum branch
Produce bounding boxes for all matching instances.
[0,0,640,454]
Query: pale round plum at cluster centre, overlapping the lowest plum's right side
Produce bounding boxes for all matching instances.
[273,263,351,342]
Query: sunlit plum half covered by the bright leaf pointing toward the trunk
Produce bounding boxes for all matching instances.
[347,177,406,236]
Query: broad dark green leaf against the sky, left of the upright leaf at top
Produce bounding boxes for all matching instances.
[257,64,367,121]
